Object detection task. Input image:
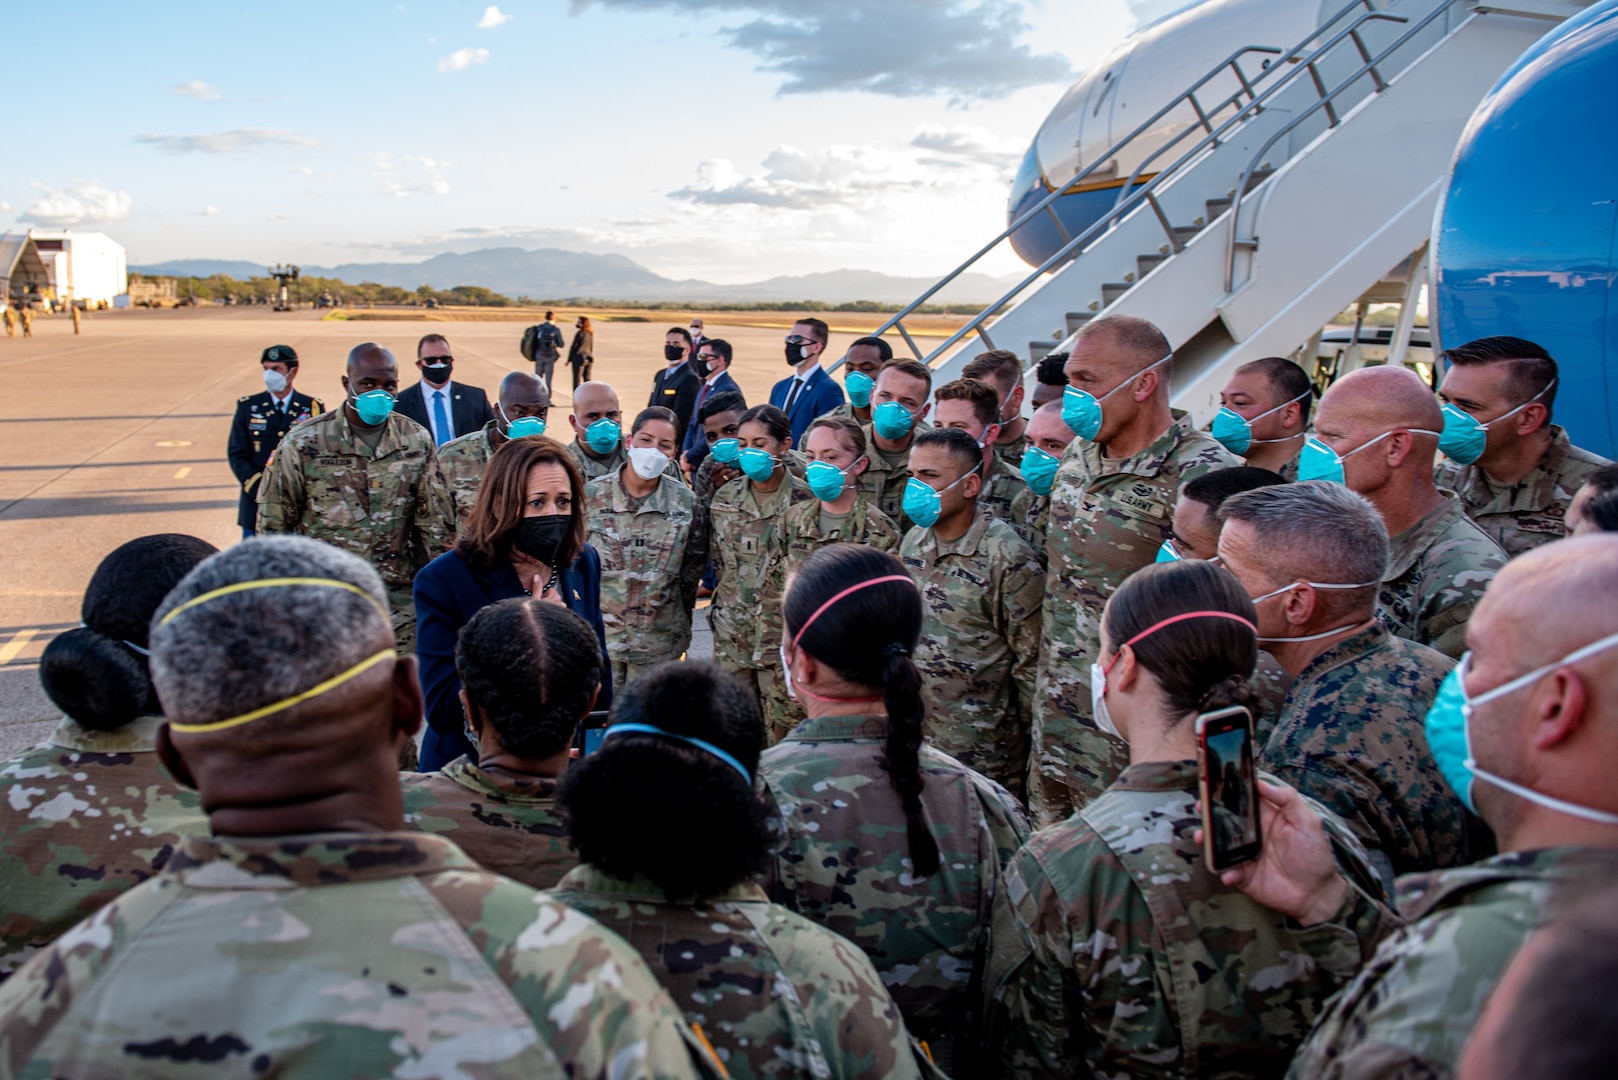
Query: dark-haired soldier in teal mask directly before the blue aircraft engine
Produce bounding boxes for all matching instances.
[1435,337,1610,555]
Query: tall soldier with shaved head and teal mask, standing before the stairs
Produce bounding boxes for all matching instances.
[1024,316,1236,824]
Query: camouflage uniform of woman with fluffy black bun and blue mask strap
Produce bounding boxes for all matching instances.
[550,865,944,1080]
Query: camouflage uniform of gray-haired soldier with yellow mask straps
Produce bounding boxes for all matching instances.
[0,832,715,1077]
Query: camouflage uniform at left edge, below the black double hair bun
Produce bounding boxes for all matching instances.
[0,716,207,977]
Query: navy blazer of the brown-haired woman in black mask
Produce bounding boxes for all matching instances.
[416,544,612,772]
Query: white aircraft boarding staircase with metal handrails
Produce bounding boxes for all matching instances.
[882,0,1586,423]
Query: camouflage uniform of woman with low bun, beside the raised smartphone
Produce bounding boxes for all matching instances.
[984,761,1383,1080]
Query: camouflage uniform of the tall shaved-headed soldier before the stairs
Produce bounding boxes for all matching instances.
[1027,410,1238,824]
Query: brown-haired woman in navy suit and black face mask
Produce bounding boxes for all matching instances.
[416,436,612,772]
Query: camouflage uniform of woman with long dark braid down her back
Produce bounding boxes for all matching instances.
[759,714,1027,1075]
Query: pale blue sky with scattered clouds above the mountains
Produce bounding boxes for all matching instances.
[0,0,1184,282]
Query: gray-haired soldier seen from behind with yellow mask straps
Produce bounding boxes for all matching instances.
[0,538,715,1077]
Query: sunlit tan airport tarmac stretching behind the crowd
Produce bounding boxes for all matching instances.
[0,308,886,758]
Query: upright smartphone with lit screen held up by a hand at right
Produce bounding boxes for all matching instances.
[1197,704,1262,874]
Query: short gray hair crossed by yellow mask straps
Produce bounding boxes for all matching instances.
[150,536,393,724]
